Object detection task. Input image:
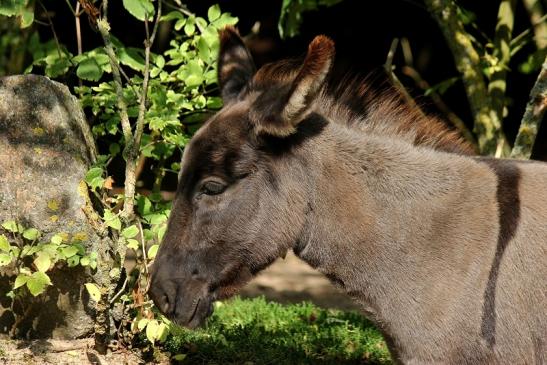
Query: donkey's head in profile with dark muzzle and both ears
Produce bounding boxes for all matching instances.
[150,28,334,327]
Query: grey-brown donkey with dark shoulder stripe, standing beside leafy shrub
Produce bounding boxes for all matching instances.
[149,28,547,364]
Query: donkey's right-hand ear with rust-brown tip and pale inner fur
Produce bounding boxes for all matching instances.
[256,35,335,137]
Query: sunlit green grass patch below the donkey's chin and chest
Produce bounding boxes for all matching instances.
[165,297,391,365]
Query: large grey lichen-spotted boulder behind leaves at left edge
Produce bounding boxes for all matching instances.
[0,75,101,339]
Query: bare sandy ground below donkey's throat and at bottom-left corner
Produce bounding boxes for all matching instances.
[0,254,364,365]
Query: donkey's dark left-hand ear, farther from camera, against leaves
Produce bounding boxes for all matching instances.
[218,26,256,104]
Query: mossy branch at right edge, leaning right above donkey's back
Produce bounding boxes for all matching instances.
[511,57,547,159]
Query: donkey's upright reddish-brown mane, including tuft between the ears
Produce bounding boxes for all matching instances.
[255,59,474,155]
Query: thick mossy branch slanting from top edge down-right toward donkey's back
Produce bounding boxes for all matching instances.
[425,0,504,154]
